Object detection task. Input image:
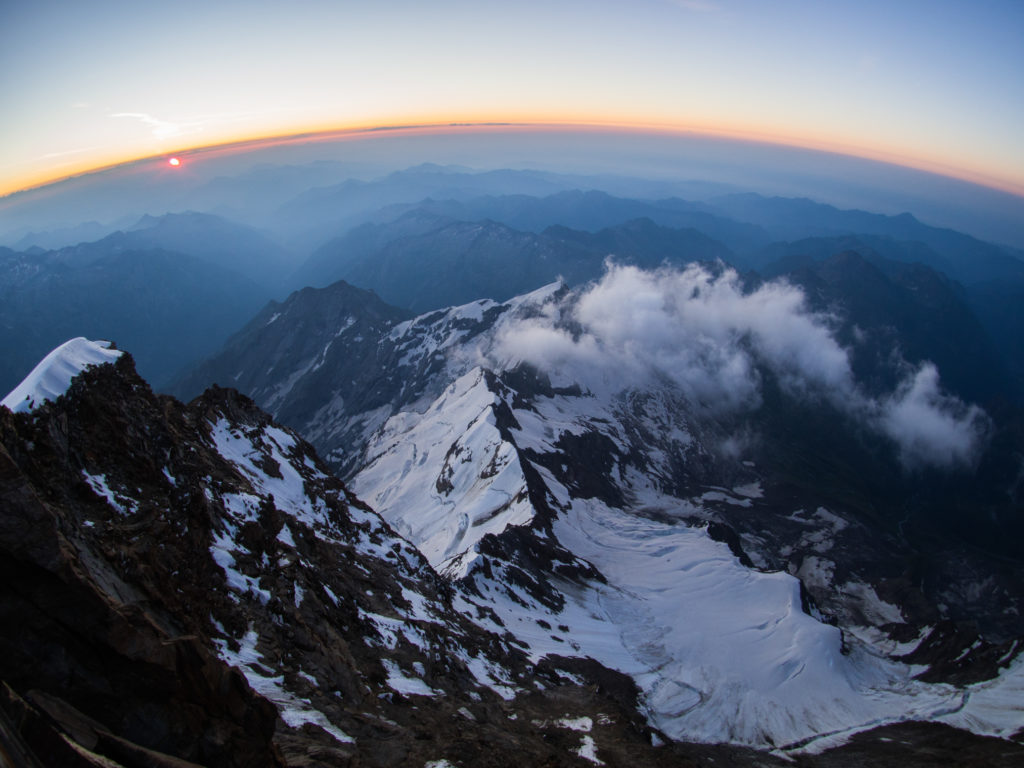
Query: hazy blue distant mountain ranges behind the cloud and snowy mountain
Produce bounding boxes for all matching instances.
[8,177,1024,409]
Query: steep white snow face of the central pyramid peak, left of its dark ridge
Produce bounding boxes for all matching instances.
[351,368,534,578]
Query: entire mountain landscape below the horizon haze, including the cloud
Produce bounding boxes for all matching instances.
[0,160,1024,768]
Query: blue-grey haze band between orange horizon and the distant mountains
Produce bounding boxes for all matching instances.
[0,126,1024,248]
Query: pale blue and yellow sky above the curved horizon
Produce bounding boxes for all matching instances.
[0,0,1024,194]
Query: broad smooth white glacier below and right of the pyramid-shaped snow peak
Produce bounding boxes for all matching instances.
[554,500,959,745]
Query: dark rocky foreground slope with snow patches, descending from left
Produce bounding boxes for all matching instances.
[0,354,742,766]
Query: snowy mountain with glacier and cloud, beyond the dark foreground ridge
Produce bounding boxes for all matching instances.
[169,266,1024,754]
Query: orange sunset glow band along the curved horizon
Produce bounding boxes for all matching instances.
[6,119,1024,201]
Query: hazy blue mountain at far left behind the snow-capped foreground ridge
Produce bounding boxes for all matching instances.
[0,244,268,389]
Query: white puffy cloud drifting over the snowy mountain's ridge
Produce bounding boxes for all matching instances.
[490,263,987,467]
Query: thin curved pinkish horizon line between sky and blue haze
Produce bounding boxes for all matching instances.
[6,121,1024,201]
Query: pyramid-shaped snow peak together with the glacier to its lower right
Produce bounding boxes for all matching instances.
[353,368,991,748]
